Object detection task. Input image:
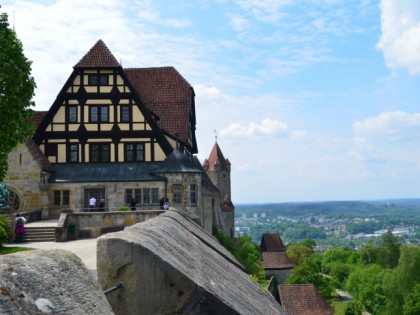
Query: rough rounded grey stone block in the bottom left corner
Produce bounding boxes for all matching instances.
[0,249,114,315]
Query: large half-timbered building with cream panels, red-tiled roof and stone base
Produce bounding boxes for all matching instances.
[7,40,233,233]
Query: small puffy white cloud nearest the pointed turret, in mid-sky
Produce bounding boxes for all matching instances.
[220,118,287,138]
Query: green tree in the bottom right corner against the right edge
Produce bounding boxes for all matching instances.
[383,246,420,314]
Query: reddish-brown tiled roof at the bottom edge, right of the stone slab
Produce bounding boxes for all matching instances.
[278,284,334,315]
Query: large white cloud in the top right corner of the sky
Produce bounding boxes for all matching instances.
[377,0,420,74]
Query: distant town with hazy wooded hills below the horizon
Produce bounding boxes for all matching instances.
[235,199,420,250]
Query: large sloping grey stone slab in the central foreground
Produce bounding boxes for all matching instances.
[97,211,284,315]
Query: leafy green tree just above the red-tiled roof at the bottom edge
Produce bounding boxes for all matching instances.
[286,255,332,297]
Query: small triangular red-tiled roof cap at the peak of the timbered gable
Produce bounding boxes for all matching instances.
[74,39,121,68]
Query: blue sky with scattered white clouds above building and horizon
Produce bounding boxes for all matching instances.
[0,0,420,204]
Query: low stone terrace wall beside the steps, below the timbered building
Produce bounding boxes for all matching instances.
[55,210,165,242]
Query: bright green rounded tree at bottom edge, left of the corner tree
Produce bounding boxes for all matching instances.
[346,264,388,314]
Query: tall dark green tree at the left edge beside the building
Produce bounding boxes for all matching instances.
[0,13,36,181]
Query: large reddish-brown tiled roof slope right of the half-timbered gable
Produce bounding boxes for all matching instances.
[124,67,197,149]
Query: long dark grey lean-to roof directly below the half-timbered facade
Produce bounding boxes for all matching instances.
[50,163,164,183]
